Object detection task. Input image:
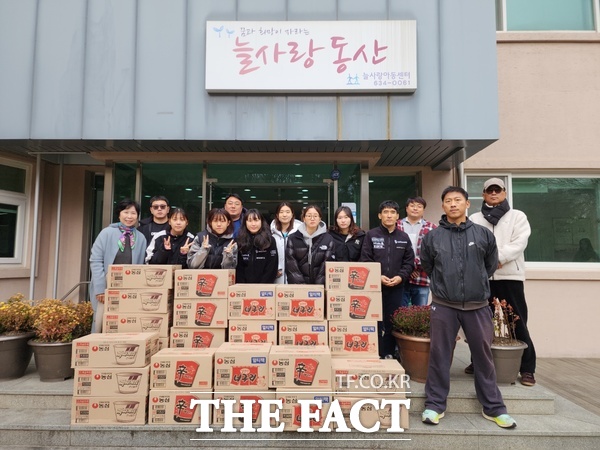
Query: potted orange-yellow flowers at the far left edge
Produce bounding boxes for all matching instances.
[0,294,34,380]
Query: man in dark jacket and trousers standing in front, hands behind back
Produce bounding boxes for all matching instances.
[421,186,517,428]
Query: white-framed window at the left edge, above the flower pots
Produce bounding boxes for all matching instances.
[0,160,29,264]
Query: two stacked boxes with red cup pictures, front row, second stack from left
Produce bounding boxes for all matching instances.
[148,348,215,425]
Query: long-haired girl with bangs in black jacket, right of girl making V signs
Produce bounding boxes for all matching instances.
[235,209,279,284]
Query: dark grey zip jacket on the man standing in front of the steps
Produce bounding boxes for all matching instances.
[421,215,498,304]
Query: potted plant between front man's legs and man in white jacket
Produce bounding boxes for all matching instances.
[490,298,527,384]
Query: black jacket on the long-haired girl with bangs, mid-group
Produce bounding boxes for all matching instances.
[235,234,279,284]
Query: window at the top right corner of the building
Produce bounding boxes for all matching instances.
[496,0,598,31]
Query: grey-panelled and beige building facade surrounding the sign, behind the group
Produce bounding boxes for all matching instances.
[0,0,600,357]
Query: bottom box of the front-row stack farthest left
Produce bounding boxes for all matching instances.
[71,393,148,425]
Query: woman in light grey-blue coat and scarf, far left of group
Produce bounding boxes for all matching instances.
[90,198,146,333]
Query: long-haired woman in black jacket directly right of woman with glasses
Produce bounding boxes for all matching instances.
[329,206,365,261]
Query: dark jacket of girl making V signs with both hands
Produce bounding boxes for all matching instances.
[188,225,237,269]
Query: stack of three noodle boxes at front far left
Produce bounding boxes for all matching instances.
[71,332,160,425]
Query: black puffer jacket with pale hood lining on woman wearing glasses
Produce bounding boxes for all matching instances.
[285,222,335,284]
